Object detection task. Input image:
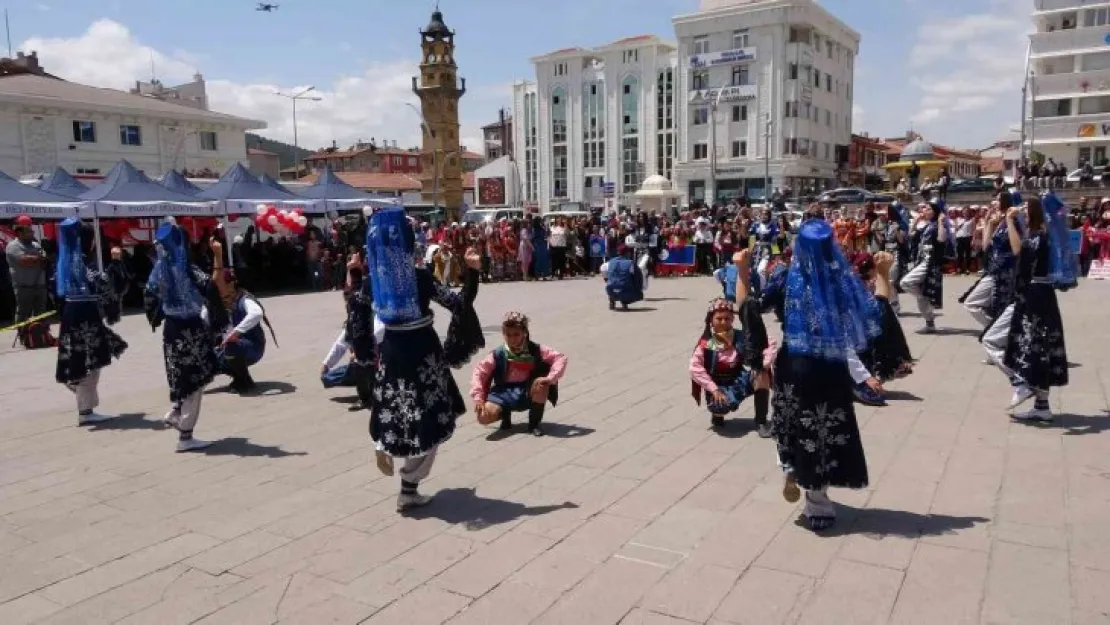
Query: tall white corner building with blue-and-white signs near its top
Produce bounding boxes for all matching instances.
[674,0,860,202]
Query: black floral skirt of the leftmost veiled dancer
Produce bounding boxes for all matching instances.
[54,300,128,384]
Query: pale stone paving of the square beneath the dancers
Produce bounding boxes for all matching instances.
[0,279,1110,625]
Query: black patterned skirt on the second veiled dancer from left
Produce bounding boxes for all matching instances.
[162,316,220,402]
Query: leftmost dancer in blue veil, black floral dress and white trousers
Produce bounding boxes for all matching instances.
[54,218,128,425]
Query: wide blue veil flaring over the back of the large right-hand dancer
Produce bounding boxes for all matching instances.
[783,221,881,361]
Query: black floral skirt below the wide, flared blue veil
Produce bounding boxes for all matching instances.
[771,345,867,491]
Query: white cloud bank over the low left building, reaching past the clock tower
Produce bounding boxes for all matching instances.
[21,19,499,152]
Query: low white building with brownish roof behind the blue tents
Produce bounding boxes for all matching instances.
[0,52,266,178]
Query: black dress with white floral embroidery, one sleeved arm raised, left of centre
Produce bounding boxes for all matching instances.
[370,268,485,457]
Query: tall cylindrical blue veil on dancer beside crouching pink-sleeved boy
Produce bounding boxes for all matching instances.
[366,208,424,325]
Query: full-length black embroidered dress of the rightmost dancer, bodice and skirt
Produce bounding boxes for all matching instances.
[1003,232,1068,390]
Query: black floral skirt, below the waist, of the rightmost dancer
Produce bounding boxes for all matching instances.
[1005,284,1068,391]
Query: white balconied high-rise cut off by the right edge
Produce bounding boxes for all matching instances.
[1026,0,1110,168]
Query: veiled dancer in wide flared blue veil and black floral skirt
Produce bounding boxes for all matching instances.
[771,220,879,532]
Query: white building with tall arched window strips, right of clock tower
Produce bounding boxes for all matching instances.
[512,34,679,210]
